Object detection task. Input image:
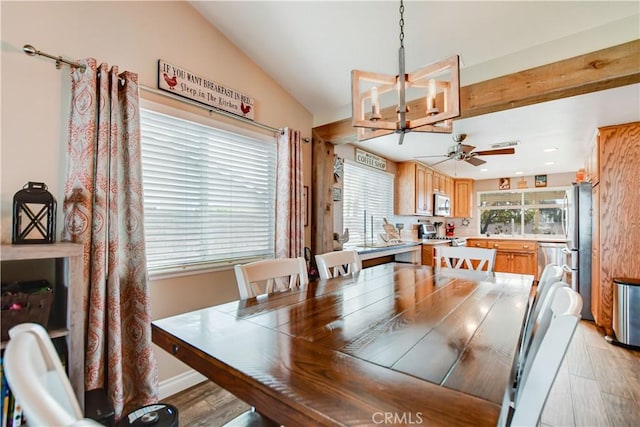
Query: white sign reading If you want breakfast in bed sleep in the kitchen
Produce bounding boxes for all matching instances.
[158,59,255,120]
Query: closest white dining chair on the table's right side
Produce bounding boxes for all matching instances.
[498,286,582,426]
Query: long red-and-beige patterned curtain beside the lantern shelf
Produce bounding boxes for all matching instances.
[63,59,158,418]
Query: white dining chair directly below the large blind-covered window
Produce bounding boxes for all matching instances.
[234,257,309,299]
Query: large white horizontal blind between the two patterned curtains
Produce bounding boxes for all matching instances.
[140,109,276,272]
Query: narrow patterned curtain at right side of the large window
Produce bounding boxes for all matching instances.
[275,128,304,258]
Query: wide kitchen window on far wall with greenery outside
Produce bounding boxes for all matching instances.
[478,188,567,236]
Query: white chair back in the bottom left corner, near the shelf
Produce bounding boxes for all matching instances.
[3,323,101,426]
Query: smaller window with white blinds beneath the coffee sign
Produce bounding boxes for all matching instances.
[342,161,393,246]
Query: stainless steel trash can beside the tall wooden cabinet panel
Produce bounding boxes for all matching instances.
[613,277,640,347]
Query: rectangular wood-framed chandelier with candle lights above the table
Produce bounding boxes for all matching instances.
[351,54,460,141]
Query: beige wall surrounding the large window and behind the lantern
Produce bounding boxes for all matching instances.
[0,1,312,388]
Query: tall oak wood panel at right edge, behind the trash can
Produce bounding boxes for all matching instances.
[597,122,640,334]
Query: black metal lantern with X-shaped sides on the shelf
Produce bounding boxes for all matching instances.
[11,182,56,244]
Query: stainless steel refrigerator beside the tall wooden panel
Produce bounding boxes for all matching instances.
[564,182,593,320]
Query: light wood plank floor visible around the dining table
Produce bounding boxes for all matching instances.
[163,321,640,427]
